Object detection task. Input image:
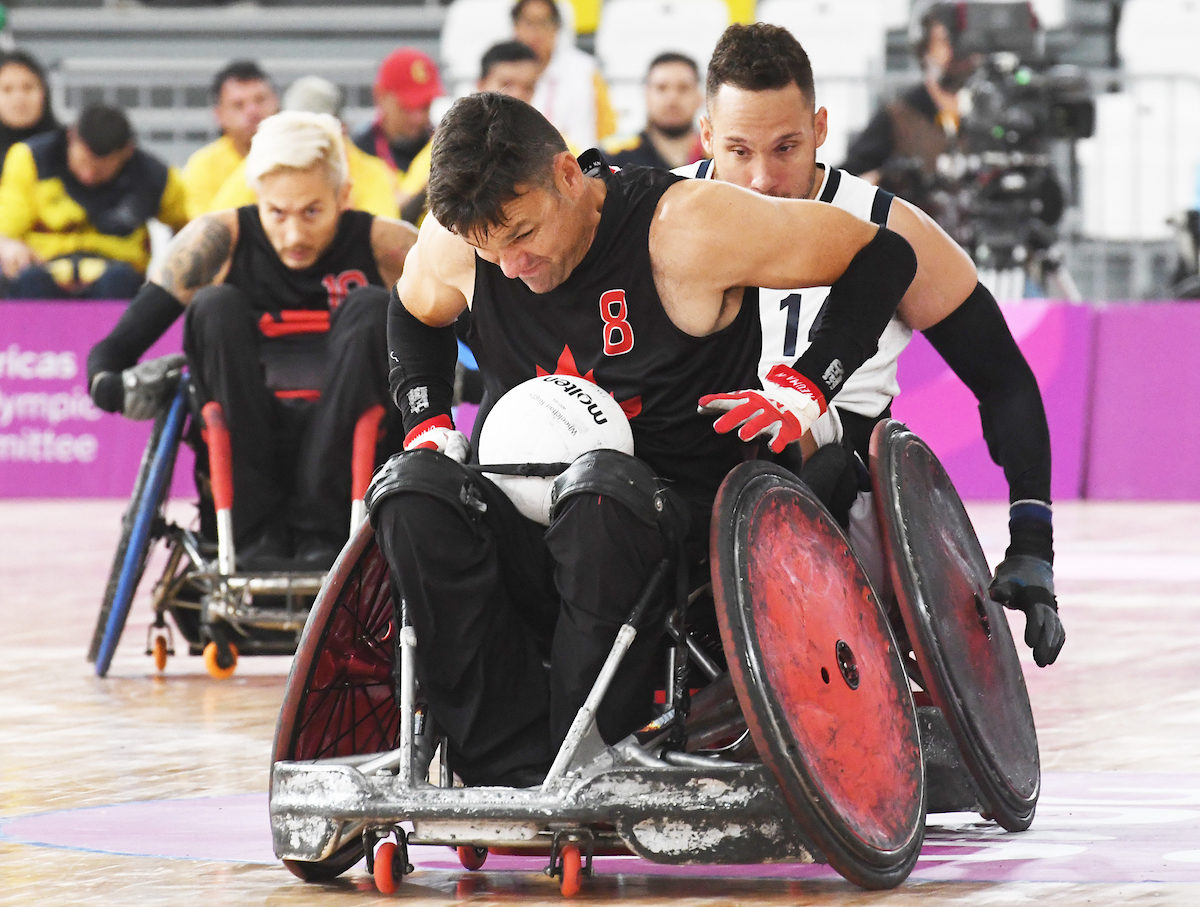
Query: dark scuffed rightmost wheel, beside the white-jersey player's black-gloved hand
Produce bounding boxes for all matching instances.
[871,420,1042,831]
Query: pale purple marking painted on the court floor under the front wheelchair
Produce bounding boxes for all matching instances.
[7,771,1200,883]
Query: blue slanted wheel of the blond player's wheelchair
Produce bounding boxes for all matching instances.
[88,374,188,677]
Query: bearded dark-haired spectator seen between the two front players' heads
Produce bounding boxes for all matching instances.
[604,52,704,170]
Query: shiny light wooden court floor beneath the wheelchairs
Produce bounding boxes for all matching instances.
[0,500,1200,907]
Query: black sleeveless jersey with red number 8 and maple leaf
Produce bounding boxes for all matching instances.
[470,167,760,506]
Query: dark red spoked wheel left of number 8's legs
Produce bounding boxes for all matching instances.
[271,523,400,882]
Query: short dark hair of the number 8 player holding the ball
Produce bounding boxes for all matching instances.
[428,91,566,236]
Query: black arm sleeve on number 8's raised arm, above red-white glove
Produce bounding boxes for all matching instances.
[792,227,917,401]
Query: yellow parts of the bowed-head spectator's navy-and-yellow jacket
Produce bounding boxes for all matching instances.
[0,142,187,274]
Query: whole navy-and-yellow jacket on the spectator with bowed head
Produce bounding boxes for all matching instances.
[0,130,187,274]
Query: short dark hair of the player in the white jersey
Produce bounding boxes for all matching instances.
[706,22,816,107]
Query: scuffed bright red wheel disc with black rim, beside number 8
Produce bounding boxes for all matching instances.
[710,461,925,888]
